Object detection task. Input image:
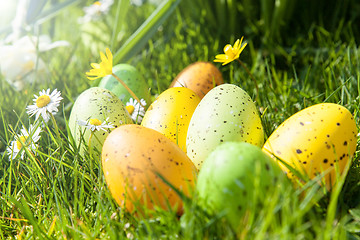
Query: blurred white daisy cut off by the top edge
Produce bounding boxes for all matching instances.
[78,0,114,23]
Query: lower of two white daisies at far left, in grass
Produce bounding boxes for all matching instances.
[6,125,41,159]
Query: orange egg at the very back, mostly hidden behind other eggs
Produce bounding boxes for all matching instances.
[170,62,224,98]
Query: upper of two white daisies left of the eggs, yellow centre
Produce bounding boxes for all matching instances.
[26,88,63,122]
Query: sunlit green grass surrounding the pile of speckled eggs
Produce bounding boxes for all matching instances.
[0,0,360,239]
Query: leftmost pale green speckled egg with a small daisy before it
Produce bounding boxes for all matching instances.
[69,87,132,157]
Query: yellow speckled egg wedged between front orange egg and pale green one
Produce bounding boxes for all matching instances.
[141,87,200,152]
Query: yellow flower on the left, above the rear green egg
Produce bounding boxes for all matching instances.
[86,48,113,80]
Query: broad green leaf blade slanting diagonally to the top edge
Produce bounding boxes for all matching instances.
[114,0,181,63]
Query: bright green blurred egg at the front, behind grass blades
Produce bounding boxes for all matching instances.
[196,142,292,230]
